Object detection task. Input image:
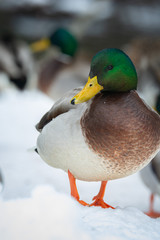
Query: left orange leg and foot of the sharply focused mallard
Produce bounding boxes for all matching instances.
[68,170,89,206]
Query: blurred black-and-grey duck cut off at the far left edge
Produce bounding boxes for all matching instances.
[0,34,36,90]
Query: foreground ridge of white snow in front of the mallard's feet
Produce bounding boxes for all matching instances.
[0,186,160,240]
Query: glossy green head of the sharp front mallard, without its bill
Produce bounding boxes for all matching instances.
[89,48,137,92]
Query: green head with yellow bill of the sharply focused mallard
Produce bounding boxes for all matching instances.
[71,48,137,104]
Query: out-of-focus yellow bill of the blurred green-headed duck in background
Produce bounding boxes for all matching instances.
[30,38,51,52]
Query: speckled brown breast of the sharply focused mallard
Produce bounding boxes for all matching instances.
[81,91,160,179]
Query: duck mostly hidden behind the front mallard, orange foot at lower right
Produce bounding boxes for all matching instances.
[140,93,160,218]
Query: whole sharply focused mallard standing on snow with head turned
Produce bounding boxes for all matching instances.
[36,48,160,208]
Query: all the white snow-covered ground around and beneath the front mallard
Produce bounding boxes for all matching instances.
[0,90,160,240]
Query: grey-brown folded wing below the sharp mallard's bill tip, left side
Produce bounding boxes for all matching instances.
[36,87,83,132]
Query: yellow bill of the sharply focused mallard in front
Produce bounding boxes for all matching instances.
[71,76,103,105]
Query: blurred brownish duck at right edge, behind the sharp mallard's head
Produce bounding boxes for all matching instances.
[125,38,160,107]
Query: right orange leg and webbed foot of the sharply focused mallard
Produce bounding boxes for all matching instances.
[89,181,114,209]
